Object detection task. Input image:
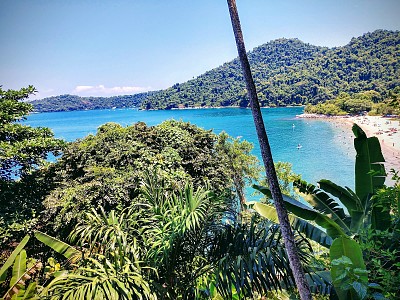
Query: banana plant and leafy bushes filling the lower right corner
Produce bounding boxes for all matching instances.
[253,125,400,299]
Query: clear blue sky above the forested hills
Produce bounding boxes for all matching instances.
[0,0,400,98]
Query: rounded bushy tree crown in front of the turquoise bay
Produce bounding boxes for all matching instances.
[40,120,259,237]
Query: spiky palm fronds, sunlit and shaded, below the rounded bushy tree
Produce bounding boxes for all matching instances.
[37,174,311,299]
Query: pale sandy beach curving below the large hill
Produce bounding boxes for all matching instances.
[296,114,400,175]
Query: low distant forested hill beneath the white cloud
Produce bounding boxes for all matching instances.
[30,92,154,112]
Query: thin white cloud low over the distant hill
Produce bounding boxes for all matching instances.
[72,84,150,96]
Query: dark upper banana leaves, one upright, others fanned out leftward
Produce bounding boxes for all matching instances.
[295,124,390,236]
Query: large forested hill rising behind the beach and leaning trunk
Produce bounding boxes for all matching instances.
[142,30,400,109]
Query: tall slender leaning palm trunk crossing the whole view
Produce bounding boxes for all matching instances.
[227,0,311,300]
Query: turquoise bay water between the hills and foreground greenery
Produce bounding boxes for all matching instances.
[26,107,355,187]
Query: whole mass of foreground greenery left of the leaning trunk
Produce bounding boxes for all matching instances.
[0,85,322,299]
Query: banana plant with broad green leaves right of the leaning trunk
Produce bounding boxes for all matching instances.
[253,124,390,299]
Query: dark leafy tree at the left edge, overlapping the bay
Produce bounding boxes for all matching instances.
[0,86,65,257]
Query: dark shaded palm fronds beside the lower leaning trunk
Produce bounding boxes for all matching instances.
[212,218,311,299]
